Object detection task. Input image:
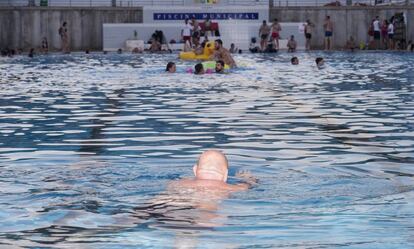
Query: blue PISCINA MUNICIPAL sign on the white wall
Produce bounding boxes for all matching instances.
[153,12,259,21]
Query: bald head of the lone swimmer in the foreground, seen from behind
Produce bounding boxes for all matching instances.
[193,150,228,182]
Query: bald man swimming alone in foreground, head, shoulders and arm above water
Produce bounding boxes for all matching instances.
[170,150,257,191]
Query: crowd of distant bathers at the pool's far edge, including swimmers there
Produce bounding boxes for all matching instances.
[0,16,414,75]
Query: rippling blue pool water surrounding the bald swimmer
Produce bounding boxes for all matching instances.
[0,52,414,248]
